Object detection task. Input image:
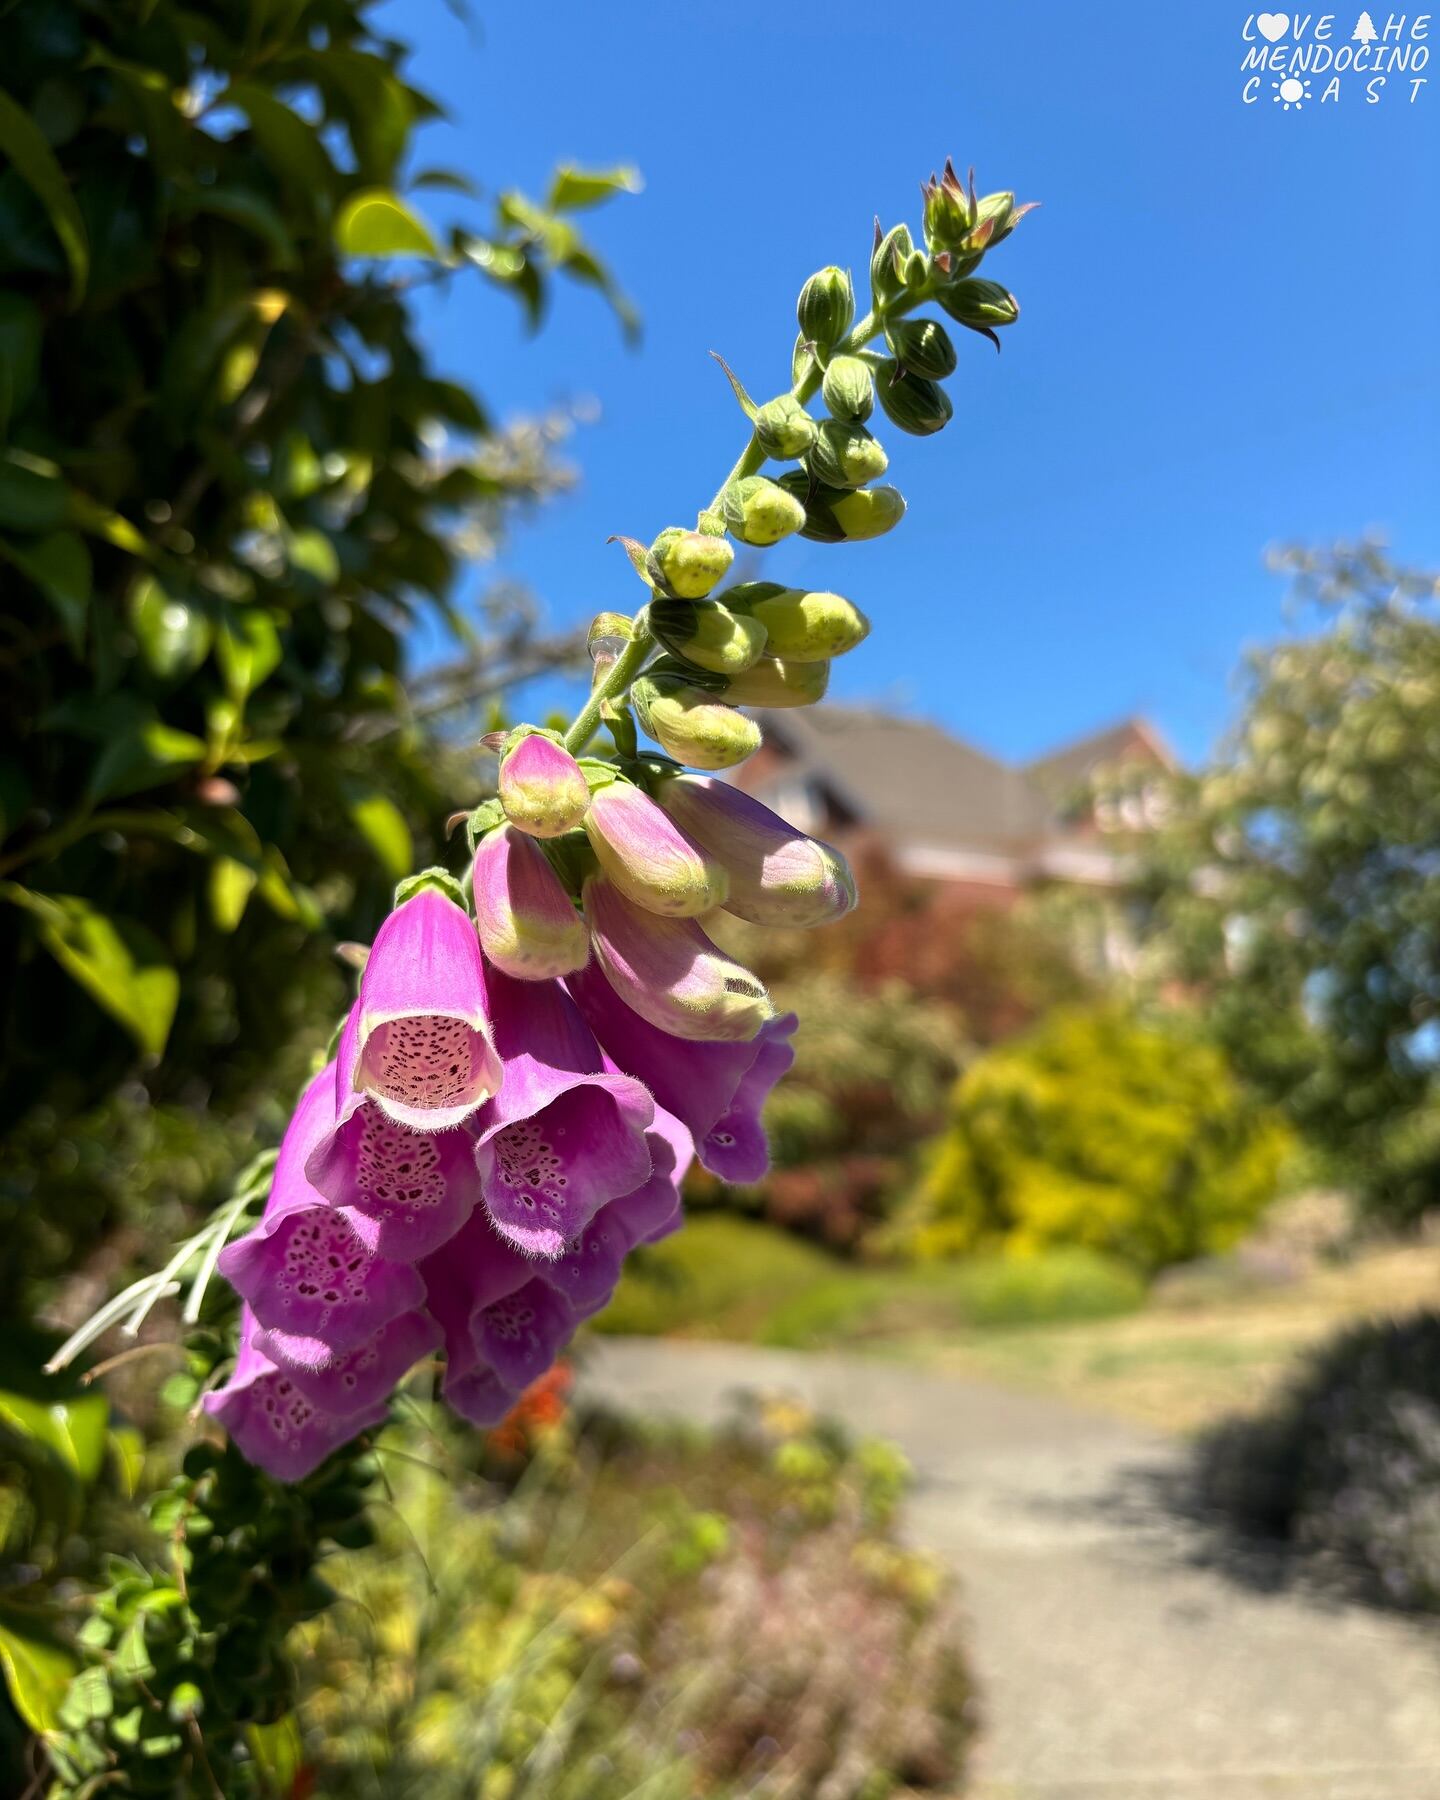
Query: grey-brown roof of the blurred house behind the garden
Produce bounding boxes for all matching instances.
[760,706,1172,853]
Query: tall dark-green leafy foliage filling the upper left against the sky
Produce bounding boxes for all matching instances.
[0,0,634,1296]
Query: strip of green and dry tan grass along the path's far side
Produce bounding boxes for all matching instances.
[596,1213,1440,1431]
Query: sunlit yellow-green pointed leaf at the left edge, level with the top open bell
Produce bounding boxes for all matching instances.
[0,882,180,1057]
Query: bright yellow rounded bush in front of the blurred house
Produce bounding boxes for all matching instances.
[896,1006,1289,1273]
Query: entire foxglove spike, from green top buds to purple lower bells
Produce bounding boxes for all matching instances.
[205,162,1026,1480]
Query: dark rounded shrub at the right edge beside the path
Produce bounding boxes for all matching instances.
[1199,1312,1440,1611]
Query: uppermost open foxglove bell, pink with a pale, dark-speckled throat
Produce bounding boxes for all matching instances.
[337,887,500,1130]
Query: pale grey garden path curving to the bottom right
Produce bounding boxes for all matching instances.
[581,1337,1440,1800]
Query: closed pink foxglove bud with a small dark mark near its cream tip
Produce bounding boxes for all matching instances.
[585,875,774,1044]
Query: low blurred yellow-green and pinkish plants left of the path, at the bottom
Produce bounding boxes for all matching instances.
[299,1402,968,1800]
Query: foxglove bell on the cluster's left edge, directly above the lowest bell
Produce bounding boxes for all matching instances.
[220,1080,425,1366]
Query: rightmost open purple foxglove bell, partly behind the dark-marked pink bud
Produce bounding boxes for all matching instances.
[567,965,797,1181]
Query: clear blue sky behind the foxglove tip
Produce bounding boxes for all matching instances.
[380,0,1440,758]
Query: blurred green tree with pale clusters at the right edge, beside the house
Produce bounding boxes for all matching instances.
[1107,544,1440,1219]
